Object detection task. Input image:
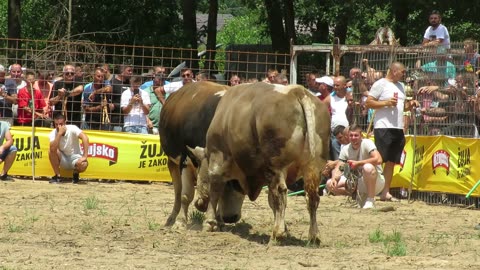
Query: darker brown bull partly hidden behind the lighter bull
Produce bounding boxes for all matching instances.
[159,81,244,226]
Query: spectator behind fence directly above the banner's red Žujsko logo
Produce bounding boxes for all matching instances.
[83,68,113,130]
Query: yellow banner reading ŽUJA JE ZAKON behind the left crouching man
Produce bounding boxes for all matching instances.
[9,127,171,181]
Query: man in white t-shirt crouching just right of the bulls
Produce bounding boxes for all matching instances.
[327,124,385,209]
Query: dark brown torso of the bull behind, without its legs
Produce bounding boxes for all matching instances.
[159,81,229,157]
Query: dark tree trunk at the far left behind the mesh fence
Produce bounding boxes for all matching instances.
[7,0,22,59]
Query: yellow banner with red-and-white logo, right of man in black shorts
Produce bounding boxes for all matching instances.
[392,136,480,196]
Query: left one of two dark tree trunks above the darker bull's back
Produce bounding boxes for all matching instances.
[182,0,198,70]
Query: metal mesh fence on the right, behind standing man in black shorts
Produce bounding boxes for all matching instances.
[296,42,479,138]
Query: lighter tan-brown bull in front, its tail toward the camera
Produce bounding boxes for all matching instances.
[194,83,330,243]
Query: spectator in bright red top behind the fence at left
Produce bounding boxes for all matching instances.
[16,72,51,127]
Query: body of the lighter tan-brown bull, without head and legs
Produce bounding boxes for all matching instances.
[207,83,330,199]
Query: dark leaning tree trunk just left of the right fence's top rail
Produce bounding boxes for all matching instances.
[264,0,289,52]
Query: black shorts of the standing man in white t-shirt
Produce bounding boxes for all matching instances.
[373,128,405,163]
